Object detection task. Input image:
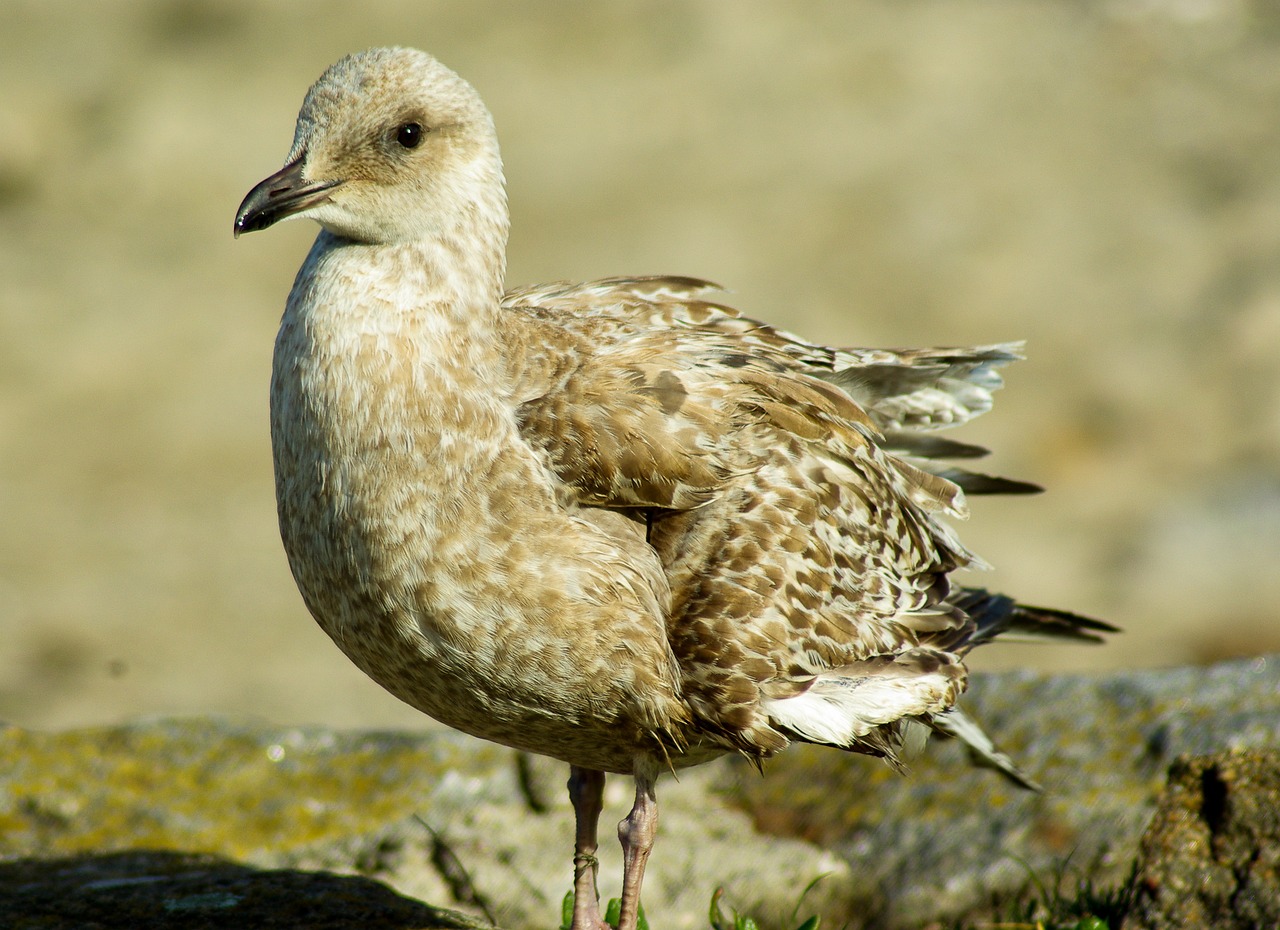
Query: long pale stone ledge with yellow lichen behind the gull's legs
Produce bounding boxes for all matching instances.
[0,658,1280,930]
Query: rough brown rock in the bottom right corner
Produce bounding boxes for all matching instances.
[1124,750,1280,930]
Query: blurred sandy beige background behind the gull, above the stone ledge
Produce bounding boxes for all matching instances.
[0,0,1280,727]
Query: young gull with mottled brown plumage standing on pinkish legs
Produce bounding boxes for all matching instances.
[234,47,1115,930]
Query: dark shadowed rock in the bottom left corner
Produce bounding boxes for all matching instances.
[0,851,489,930]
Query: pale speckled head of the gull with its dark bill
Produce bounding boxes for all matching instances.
[234,49,506,243]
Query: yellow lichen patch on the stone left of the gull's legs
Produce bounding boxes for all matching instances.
[0,720,506,860]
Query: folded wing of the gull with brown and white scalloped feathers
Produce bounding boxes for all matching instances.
[506,278,1049,760]
